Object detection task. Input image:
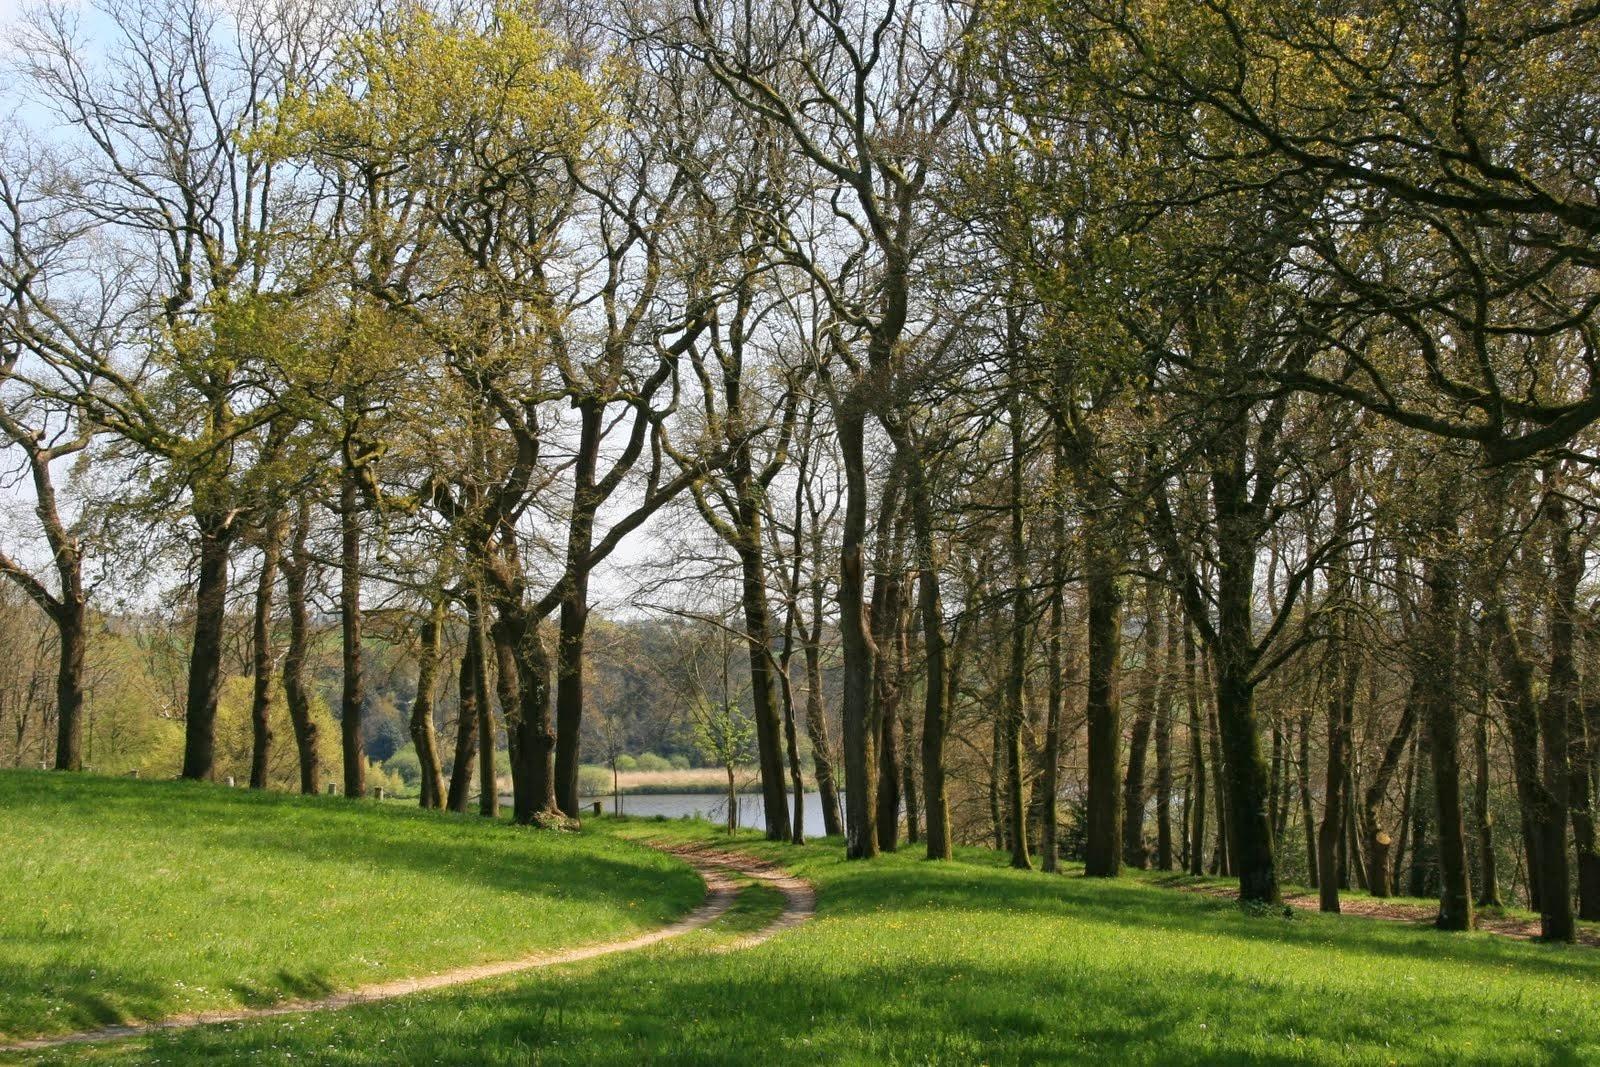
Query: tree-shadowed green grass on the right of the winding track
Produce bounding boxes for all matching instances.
[25,821,1600,1064]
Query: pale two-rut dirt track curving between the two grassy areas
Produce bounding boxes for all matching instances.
[0,846,816,1054]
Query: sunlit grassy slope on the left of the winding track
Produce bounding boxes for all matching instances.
[0,771,704,1037]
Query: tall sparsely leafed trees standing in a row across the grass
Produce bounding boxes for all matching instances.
[0,0,1600,939]
